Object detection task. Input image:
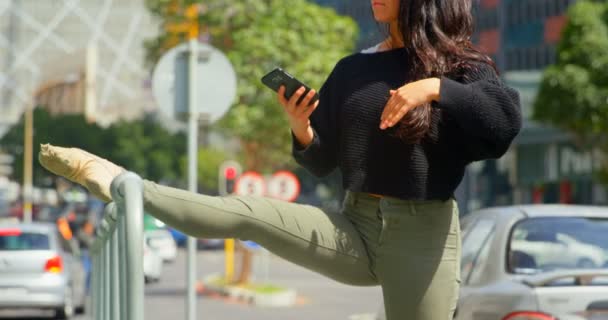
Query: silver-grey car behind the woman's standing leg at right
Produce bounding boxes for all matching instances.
[456,205,608,320]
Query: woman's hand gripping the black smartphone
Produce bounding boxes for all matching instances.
[278,86,319,146]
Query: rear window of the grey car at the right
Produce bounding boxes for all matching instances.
[508,217,608,273]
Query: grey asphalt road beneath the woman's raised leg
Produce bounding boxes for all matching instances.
[0,250,382,320]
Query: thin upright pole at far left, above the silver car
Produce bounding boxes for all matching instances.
[22,105,34,223]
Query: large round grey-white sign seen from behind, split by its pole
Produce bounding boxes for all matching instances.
[152,43,237,123]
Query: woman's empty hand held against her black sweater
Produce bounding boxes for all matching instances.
[380,78,441,130]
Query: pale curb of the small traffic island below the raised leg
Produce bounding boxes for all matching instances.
[197,274,297,307]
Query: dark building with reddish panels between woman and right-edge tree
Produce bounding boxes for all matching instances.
[460,0,607,209]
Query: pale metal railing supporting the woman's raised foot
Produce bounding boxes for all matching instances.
[91,172,144,320]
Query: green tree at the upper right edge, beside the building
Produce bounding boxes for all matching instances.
[533,0,608,179]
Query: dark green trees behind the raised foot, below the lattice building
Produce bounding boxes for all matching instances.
[0,108,186,185]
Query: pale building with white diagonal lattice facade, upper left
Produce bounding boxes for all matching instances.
[0,0,158,127]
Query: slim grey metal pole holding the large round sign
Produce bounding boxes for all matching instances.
[186,38,198,320]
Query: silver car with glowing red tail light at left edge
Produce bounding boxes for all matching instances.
[0,223,86,319]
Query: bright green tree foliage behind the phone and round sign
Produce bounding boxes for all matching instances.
[147,0,358,171]
